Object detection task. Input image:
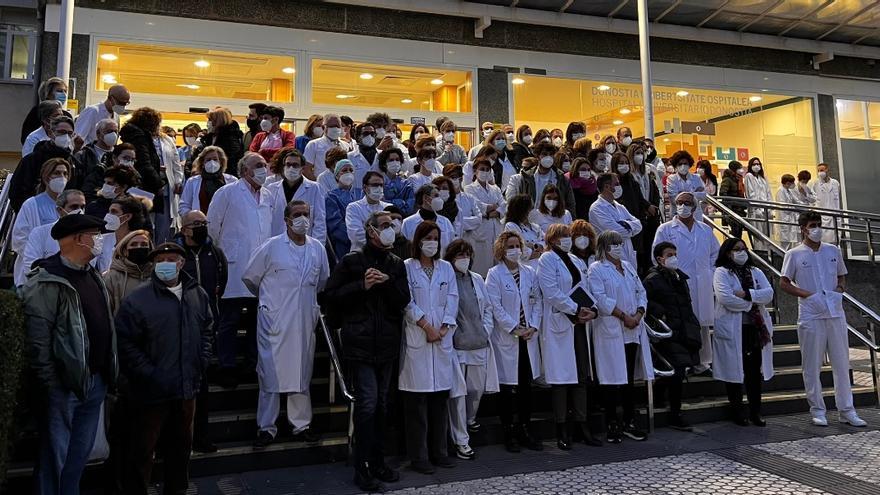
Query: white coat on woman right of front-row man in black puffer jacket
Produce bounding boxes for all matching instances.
[398,258,461,393]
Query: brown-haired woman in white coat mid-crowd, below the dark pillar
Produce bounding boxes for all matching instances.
[464,158,507,275]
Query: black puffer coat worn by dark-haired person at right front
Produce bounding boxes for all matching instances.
[643,266,702,371]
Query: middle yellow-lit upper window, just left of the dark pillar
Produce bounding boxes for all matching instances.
[312,59,473,112]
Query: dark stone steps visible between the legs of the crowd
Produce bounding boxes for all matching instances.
[0,185,880,493]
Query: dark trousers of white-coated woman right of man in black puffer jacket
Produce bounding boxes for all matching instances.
[402,390,449,462]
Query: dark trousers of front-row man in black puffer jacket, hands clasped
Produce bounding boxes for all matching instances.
[349,361,394,467]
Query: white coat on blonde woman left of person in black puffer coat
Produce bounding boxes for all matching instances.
[589,261,654,385]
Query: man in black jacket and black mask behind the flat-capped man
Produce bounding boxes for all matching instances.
[174,210,229,453]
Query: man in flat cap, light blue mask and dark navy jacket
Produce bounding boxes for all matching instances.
[116,242,214,495]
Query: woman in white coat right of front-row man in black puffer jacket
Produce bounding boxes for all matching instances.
[398,221,461,474]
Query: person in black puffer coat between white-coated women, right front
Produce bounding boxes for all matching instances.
[643,242,702,431]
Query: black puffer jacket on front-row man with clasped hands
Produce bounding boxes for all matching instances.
[323,243,410,363]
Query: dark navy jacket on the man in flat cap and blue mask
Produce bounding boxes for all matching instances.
[116,273,214,404]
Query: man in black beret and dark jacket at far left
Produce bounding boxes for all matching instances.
[21,215,118,493]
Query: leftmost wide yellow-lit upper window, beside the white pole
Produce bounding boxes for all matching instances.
[94,41,296,103]
